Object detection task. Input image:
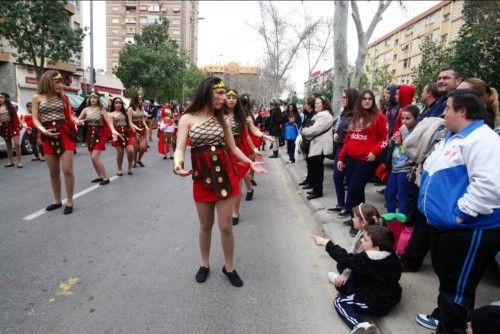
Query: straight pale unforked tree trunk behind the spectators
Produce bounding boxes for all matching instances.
[332,0,349,113]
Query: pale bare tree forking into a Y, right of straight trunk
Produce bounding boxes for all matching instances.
[350,0,391,87]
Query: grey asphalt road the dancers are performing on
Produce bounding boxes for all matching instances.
[0,144,348,333]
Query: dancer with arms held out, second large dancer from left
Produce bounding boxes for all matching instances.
[76,92,121,186]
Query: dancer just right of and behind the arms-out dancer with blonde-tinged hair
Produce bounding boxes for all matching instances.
[109,97,134,176]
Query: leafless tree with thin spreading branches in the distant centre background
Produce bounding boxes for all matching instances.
[256,1,322,97]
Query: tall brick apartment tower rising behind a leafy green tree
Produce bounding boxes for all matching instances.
[106,0,198,72]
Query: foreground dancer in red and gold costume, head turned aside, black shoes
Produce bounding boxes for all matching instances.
[174,77,267,287]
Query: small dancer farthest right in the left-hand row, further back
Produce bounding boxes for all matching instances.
[127,95,149,168]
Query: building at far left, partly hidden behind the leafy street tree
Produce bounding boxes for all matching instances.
[0,0,84,105]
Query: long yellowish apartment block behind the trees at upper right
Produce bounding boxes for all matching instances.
[365,1,464,83]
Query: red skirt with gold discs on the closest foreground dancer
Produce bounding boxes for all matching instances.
[191,146,240,203]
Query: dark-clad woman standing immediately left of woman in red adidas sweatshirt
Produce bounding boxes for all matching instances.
[328,88,359,212]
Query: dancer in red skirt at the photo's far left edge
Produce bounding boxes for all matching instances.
[0,93,23,168]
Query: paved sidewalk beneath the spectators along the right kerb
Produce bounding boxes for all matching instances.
[278,149,500,334]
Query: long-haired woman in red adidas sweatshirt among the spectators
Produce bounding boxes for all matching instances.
[337,90,387,217]
